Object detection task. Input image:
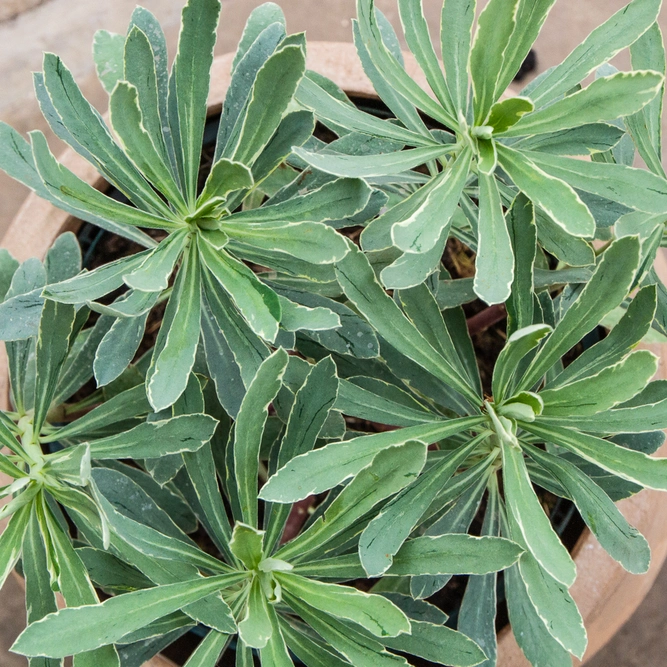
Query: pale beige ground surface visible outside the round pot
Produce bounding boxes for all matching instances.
[0,0,667,667]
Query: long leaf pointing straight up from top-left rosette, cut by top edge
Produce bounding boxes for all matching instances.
[172,0,220,205]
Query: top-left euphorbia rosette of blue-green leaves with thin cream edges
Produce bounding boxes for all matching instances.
[0,0,370,410]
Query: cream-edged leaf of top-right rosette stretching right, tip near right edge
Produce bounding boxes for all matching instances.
[501,72,663,137]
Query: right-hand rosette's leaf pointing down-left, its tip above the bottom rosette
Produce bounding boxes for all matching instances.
[359,436,486,577]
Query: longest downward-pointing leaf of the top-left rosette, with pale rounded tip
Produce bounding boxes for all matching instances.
[146,240,201,412]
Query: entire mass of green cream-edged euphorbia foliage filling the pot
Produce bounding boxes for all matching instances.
[0,0,667,667]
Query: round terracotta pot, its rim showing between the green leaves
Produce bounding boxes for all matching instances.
[0,42,667,667]
